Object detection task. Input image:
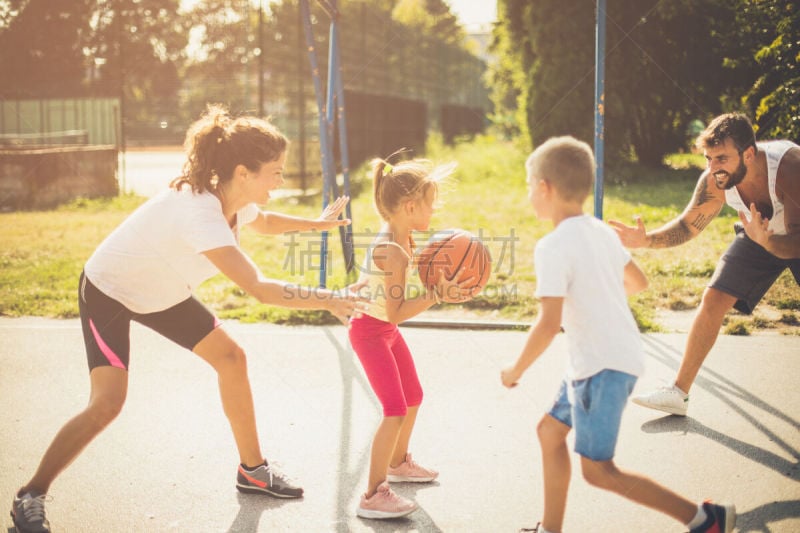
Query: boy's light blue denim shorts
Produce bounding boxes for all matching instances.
[547,370,637,461]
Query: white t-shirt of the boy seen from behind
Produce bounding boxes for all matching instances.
[534,215,644,380]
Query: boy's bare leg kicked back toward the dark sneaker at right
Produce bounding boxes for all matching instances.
[580,457,697,527]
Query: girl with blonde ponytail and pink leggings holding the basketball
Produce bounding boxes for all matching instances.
[349,154,477,519]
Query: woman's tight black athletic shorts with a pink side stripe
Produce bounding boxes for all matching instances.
[78,273,220,371]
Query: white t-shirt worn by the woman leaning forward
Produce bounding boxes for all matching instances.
[84,188,259,313]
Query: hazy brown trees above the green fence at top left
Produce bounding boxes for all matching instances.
[0,0,188,132]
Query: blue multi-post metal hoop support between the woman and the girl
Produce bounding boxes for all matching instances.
[300,0,355,287]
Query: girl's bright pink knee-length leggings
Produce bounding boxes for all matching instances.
[350,315,422,416]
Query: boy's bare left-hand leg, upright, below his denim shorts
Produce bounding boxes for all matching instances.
[536,414,572,531]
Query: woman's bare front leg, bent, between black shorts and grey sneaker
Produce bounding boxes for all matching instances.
[192,327,264,466]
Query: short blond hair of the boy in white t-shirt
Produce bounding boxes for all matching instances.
[525,135,595,202]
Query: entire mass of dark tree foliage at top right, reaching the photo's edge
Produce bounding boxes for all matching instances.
[489,0,800,166]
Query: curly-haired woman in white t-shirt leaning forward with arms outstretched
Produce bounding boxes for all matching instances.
[12,106,358,531]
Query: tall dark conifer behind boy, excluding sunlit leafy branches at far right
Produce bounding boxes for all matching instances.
[495,0,739,166]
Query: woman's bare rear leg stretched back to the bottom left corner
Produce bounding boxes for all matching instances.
[20,366,128,493]
